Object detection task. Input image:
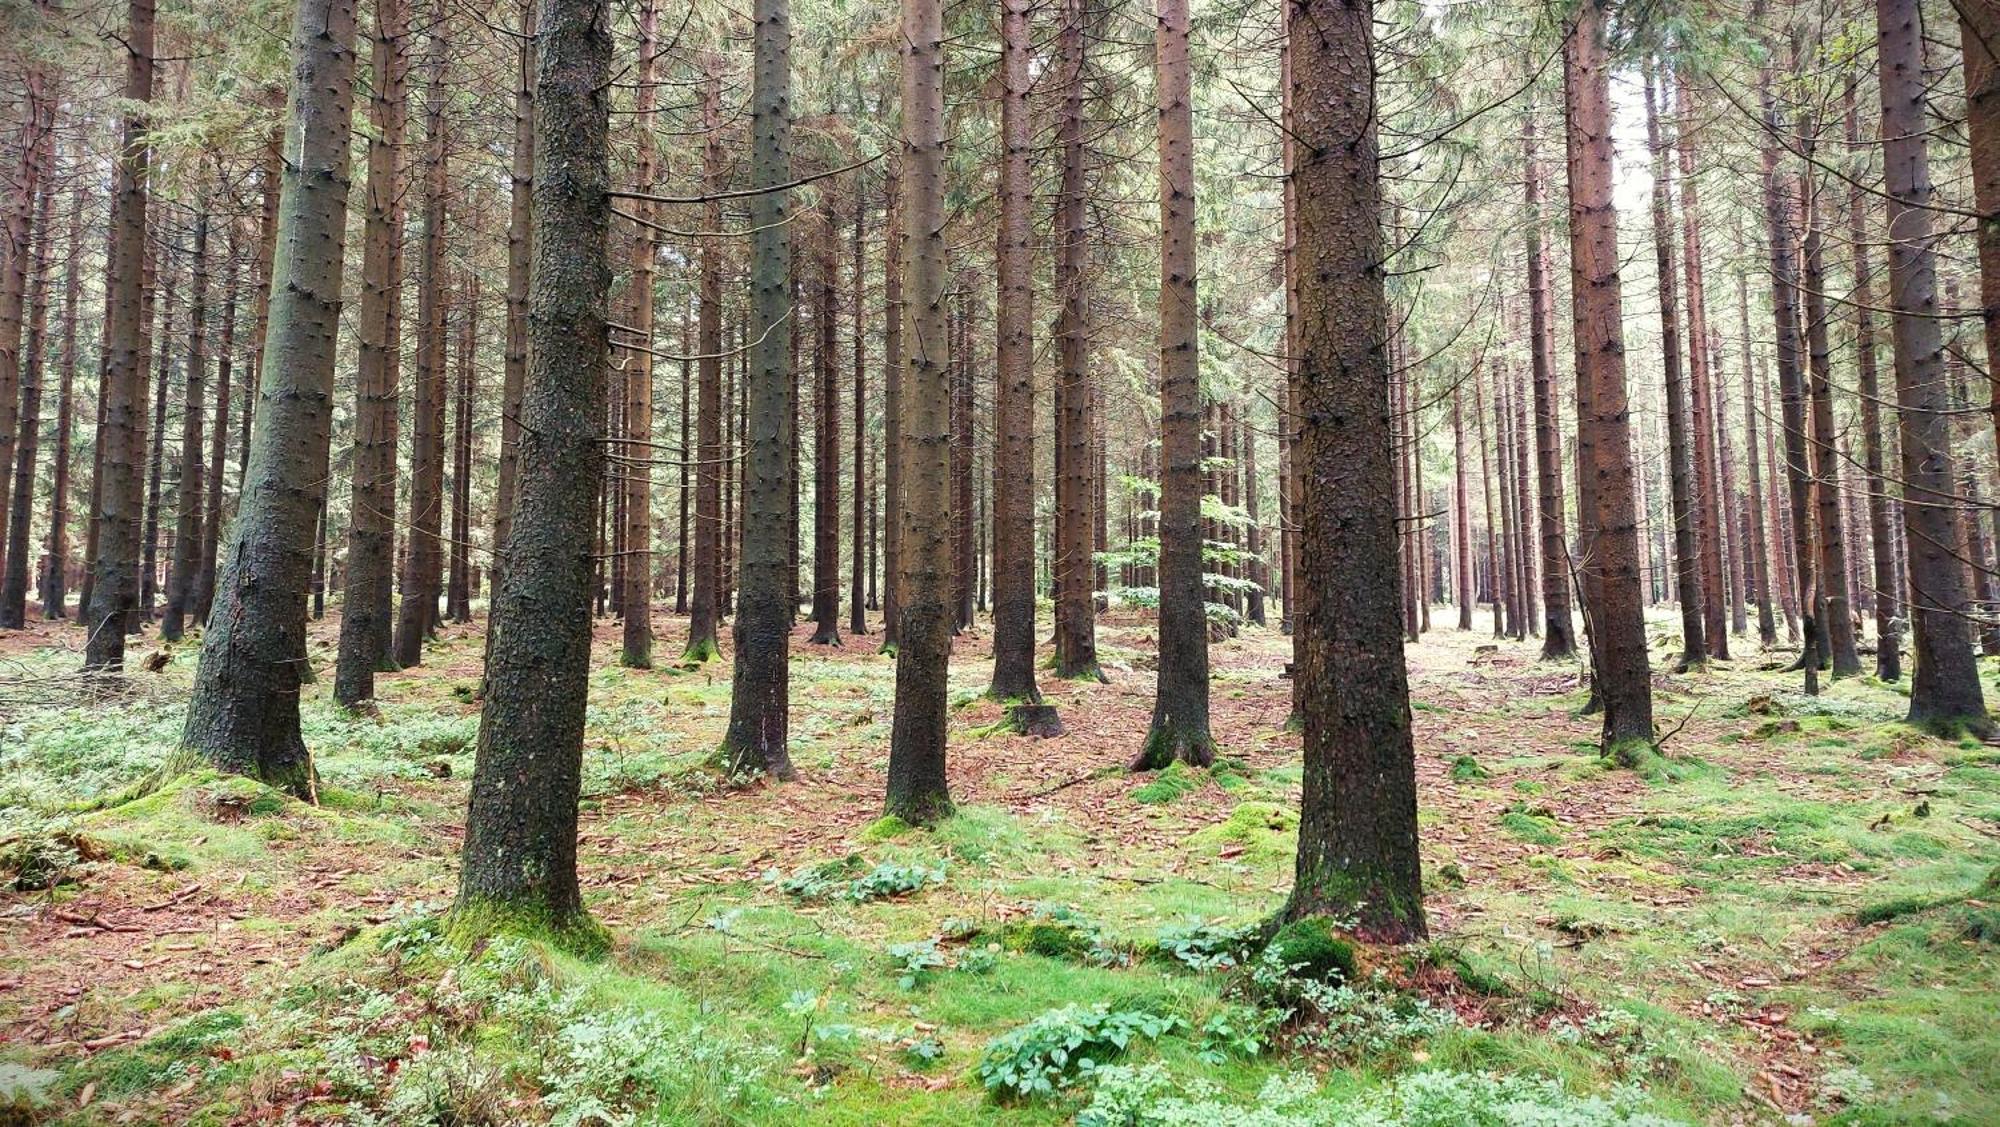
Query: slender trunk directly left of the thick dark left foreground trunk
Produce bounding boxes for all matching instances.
[488,0,532,591]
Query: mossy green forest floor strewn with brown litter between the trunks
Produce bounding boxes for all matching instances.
[0,609,2000,1127]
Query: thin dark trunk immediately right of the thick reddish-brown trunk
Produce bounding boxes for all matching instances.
[1644,66,1708,671]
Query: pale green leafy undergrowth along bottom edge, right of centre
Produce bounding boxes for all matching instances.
[1076,1061,1678,1127]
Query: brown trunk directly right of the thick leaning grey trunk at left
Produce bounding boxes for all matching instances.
[334,0,408,707]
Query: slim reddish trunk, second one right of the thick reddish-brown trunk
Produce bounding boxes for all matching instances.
[1660,72,1740,661]
